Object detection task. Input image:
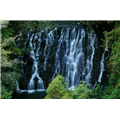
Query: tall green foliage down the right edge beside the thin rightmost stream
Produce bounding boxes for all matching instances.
[101,20,120,99]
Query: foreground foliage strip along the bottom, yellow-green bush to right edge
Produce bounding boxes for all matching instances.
[44,75,120,99]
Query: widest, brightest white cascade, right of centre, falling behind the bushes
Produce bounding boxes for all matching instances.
[66,28,85,89]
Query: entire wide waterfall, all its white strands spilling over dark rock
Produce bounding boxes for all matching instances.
[16,27,108,93]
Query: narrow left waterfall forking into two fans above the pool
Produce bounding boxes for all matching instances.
[28,33,44,93]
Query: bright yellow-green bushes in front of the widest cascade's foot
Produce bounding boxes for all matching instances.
[45,75,94,99]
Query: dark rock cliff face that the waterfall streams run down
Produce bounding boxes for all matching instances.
[19,27,109,90]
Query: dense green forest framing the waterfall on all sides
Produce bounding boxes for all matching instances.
[0,20,120,99]
